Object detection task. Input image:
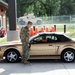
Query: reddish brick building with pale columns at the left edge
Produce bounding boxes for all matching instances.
[0,0,8,30]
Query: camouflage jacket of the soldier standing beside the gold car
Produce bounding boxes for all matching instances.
[20,26,29,44]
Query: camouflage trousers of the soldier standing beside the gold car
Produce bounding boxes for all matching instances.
[22,43,30,61]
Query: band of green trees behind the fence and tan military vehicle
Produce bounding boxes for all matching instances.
[4,0,75,17]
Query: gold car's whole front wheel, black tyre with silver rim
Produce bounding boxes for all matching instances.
[5,51,19,63]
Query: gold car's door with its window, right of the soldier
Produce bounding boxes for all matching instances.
[30,35,55,55]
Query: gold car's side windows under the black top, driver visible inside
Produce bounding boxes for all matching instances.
[31,35,60,44]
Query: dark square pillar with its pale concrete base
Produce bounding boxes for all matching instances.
[7,0,19,41]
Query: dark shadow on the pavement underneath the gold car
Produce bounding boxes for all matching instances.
[0,59,75,63]
